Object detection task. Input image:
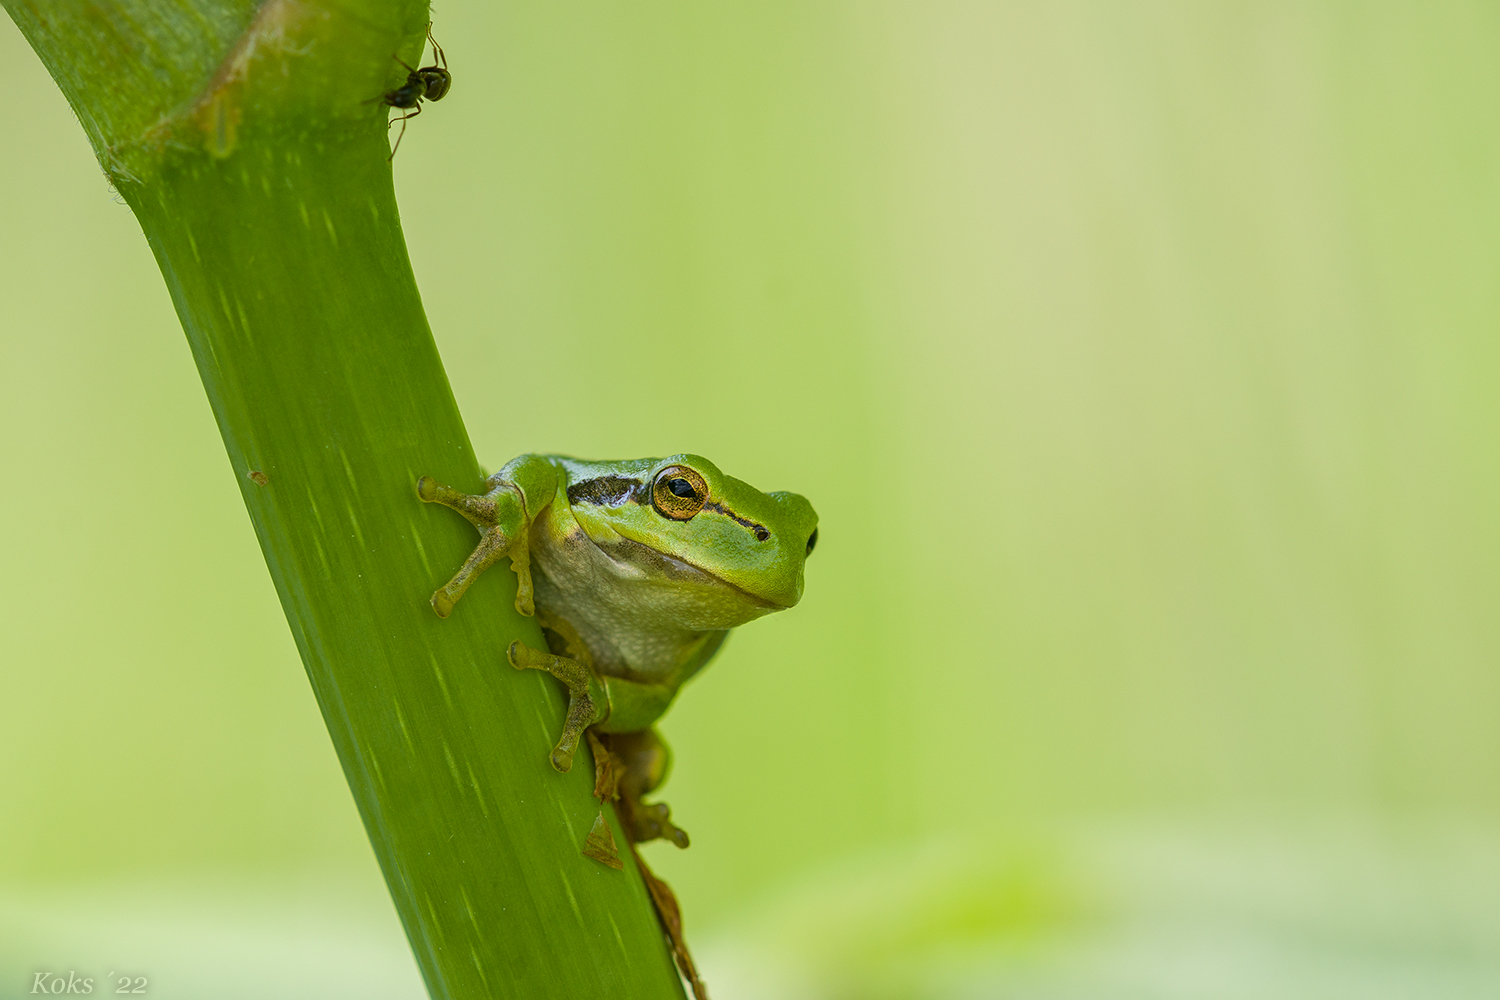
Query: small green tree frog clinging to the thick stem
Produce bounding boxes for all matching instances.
[417,454,818,867]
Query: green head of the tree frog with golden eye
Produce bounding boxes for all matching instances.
[569,454,818,628]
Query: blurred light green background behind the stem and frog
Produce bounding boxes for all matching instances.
[0,0,1500,1000]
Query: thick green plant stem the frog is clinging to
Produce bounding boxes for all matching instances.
[5,0,681,999]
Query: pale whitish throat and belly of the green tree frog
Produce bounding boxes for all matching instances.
[531,519,747,684]
